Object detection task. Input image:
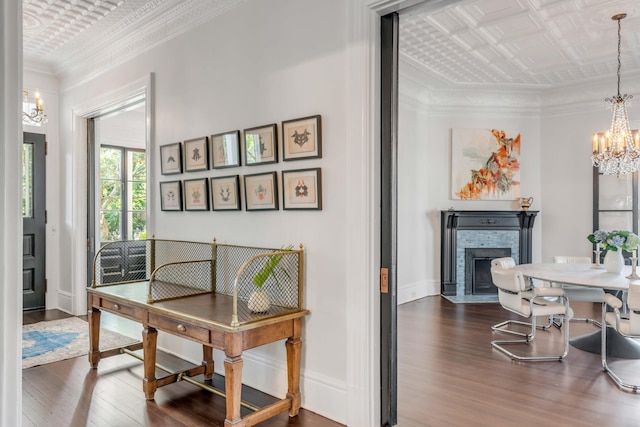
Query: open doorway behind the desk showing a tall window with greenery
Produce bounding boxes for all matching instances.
[87,100,147,283]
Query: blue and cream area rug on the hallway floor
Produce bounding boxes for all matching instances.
[22,317,137,369]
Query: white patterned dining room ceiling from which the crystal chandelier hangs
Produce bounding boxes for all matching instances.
[400,0,640,90]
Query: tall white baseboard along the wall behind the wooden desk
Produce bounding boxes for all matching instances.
[158,336,347,424]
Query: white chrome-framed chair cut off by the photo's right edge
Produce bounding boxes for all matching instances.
[601,284,640,393]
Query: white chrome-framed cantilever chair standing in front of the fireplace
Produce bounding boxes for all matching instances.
[491,260,572,361]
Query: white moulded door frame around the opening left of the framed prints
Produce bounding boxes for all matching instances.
[68,73,155,315]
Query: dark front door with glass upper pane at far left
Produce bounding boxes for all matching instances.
[22,132,46,310]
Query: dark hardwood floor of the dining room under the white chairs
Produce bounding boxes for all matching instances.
[398,297,640,427]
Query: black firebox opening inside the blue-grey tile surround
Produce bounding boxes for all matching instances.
[464,248,511,295]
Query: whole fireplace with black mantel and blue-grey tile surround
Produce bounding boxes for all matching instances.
[440,210,538,297]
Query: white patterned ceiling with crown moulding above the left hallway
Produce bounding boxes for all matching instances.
[23,0,242,79]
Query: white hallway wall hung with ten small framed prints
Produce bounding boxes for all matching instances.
[55,0,356,422]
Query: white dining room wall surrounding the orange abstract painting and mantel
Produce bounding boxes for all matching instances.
[398,62,544,303]
